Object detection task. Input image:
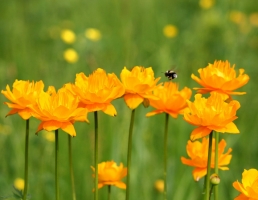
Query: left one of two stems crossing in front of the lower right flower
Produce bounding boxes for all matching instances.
[204,131,213,200]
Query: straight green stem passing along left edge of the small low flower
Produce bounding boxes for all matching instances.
[94,111,99,200]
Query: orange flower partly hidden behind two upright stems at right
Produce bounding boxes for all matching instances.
[181,137,232,181]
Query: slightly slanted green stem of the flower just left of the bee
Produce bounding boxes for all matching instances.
[126,109,135,200]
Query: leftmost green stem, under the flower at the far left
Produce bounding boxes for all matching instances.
[23,119,30,200]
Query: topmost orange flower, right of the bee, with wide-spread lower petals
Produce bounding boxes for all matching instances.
[191,61,249,97]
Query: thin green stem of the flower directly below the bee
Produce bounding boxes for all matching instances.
[163,113,169,200]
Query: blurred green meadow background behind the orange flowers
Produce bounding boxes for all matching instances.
[0,0,258,200]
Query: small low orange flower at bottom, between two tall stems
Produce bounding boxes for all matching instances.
[91,161,127,189]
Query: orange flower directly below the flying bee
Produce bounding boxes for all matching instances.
[146,82,192,118]
